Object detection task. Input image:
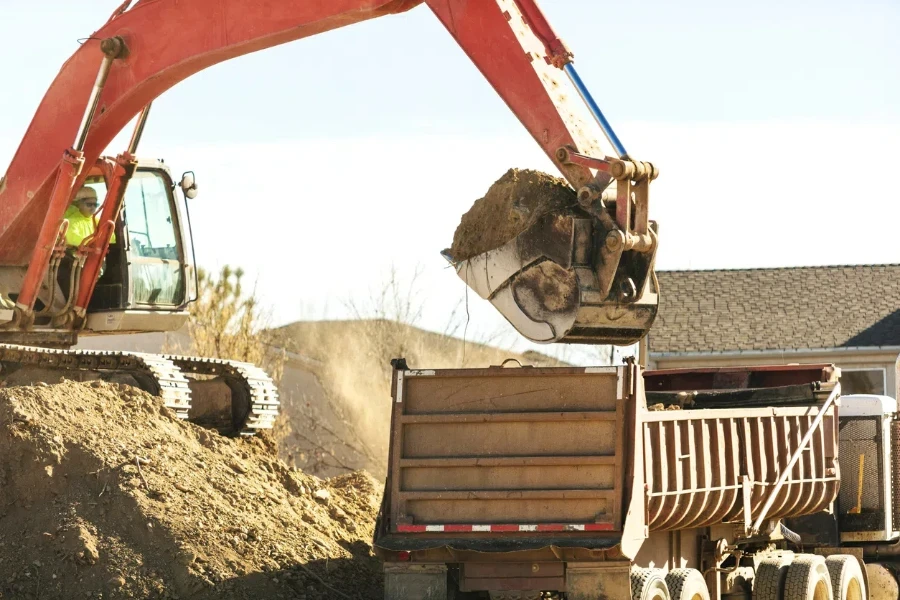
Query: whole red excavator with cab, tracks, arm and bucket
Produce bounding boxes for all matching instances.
[0,0,658,434]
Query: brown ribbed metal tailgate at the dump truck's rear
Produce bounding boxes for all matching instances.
[388,367,627,544]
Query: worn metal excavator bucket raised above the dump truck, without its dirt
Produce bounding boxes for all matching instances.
[444,162,659,346]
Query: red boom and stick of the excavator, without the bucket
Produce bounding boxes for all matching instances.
[0,0,602,264]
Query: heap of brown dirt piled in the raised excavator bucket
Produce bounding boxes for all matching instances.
[450,169,578,260]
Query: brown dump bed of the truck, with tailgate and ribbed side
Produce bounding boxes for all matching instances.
[375,361,838,600]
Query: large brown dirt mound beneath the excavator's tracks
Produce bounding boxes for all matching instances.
[0,381,381,600]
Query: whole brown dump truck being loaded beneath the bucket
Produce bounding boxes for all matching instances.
[374,360,900,600]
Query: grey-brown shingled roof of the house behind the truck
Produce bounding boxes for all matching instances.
[649,264,900,353]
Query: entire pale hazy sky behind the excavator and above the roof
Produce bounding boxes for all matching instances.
[0,0,900,360]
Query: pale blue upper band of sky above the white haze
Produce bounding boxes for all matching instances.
[0,0,900,143]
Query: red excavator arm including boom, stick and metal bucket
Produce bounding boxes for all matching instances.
[0,0,656,343]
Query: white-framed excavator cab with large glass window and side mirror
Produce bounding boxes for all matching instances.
[76,160,197,333]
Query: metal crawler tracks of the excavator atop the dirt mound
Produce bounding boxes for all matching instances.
[0,344,279,436]
